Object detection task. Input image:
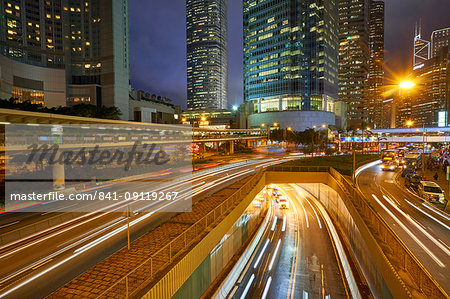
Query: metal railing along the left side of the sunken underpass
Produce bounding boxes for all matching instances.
[97,170,262,298]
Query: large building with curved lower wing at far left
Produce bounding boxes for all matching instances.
[0,0,129,119]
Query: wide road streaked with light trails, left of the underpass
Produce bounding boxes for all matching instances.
[0,158,296,298]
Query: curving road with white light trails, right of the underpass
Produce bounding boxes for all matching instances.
[357,165,450,294]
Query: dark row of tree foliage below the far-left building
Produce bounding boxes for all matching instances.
[0,98,122,119]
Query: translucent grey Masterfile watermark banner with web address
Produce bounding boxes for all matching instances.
[5,124,193,213]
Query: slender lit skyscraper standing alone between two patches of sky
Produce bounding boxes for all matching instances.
[186,0,228,110]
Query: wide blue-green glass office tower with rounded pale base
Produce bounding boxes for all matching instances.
[243,0,338,130]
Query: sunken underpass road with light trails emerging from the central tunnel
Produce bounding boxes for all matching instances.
[230,184,358,298]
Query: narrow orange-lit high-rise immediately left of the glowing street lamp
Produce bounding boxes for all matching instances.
[368,0,384,128]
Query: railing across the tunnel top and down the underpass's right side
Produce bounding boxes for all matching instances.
[267,166,448,298]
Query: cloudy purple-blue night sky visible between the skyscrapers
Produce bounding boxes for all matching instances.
[129,0,450,109]
